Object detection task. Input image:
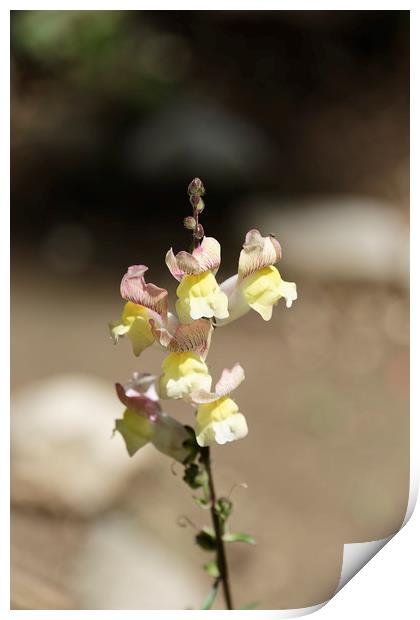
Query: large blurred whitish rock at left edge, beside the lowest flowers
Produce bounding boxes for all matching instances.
[11,374,155,515]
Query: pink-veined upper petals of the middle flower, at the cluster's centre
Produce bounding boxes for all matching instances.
[150,319,214,360]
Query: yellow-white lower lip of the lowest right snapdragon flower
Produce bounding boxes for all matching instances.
[195,396,248,446]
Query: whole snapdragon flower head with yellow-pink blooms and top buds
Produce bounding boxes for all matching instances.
[110,179,297,462]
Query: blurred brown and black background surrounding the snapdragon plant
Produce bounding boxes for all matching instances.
[11,11,409,609]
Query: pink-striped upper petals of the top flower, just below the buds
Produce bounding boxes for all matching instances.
[165,237,220,281]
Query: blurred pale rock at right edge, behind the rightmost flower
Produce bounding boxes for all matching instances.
[236,195,409,287]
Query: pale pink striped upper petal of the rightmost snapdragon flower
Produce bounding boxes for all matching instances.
[238,229,281,279]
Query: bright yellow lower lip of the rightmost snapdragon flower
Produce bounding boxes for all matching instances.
[242,265,297,321]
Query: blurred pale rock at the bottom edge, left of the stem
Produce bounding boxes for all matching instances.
[73,513,204,609]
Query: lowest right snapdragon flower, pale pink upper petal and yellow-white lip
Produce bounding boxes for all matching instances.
[191,364,248,446]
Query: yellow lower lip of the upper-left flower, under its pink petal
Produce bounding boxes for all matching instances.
[109,301,155,355]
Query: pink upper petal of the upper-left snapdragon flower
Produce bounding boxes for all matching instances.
[120,265,168,316]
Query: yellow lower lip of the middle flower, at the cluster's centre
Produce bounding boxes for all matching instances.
[159,352,211,398]
